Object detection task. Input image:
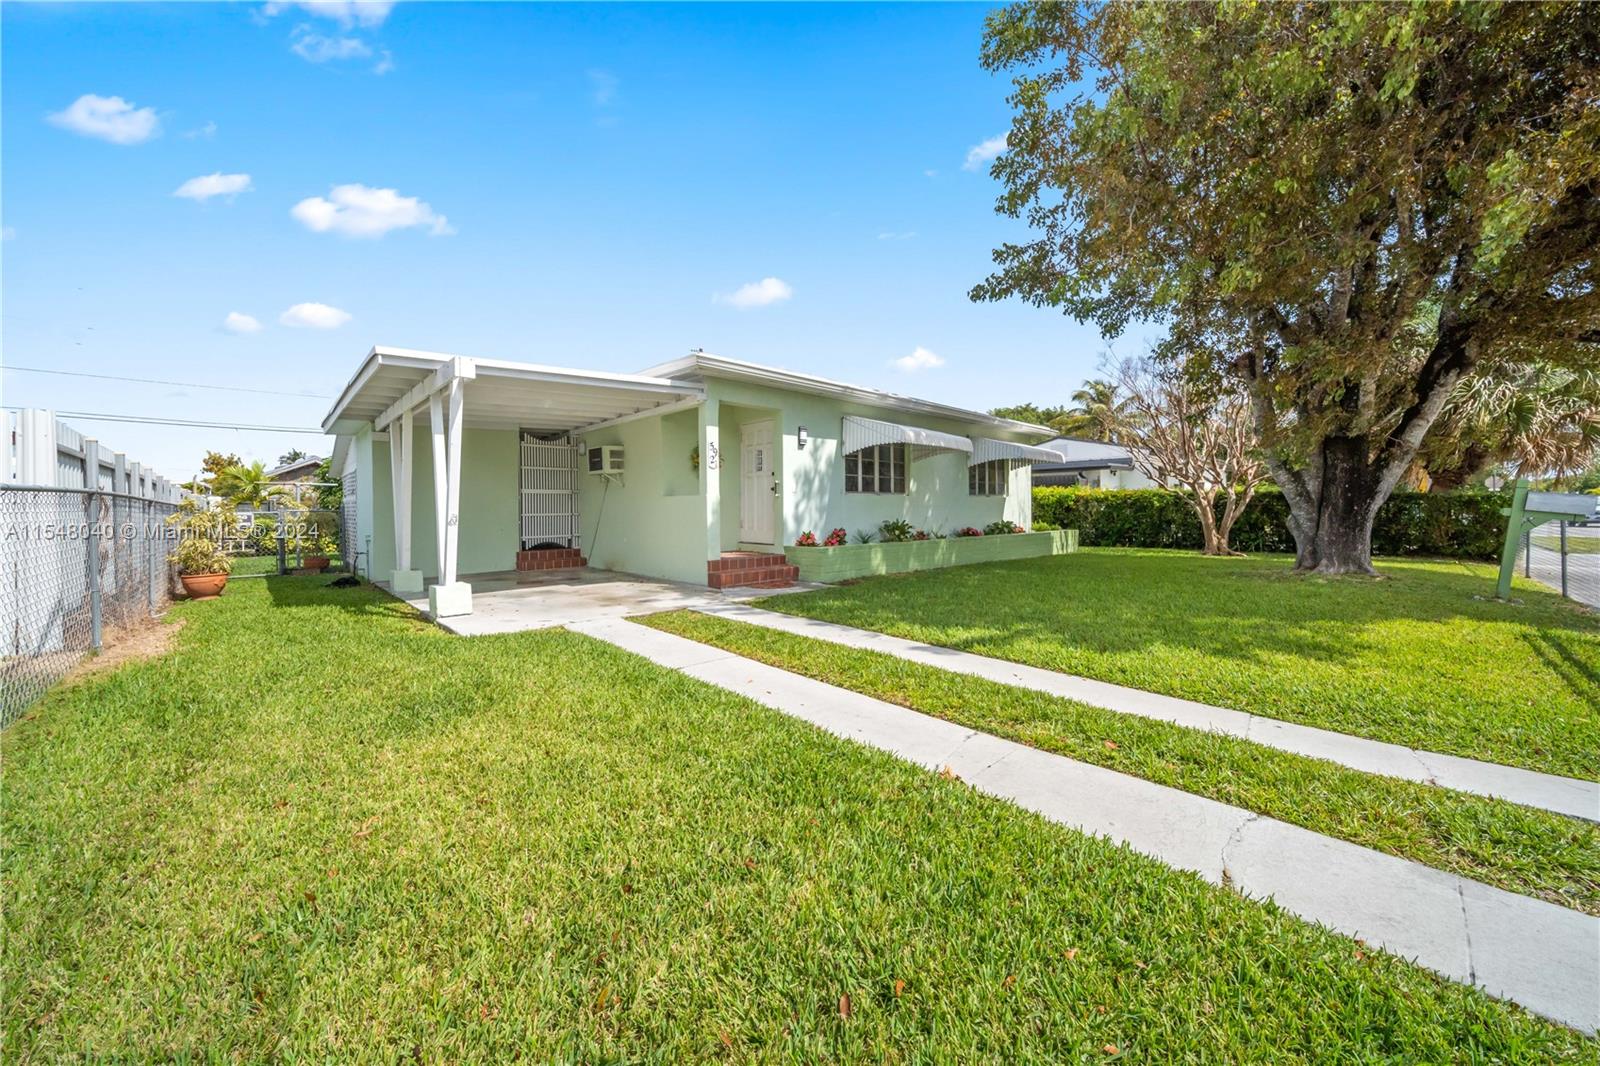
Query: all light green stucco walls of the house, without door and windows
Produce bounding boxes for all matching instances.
[352,379,1032,584]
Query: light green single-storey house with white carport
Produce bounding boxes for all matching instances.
[323,347,1061,615]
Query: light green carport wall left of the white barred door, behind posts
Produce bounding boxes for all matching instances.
[357,419,520,581]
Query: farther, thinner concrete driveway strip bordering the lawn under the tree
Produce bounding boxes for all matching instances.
[694,603,1600,821]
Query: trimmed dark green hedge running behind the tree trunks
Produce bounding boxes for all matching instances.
[1034,487,1510,560]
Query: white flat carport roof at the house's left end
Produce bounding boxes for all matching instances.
[322,347,706,434]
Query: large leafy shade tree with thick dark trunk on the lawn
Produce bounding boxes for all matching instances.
[973,3,1600,573]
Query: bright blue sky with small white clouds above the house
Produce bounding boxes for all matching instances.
[0,3,1136,477]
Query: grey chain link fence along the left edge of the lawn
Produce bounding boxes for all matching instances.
[0,488,176,727]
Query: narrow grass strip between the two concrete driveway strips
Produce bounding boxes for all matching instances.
[635,611,1600,914]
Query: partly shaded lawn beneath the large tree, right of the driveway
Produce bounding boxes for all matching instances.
[760,547,1600,781]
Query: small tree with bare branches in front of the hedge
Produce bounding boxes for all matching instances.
[1117,357,1266,555]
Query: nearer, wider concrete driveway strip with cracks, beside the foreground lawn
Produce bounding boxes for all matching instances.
[570,618,1600,1032]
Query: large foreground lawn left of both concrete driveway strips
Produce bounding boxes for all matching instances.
[0,578,1600,1063]
